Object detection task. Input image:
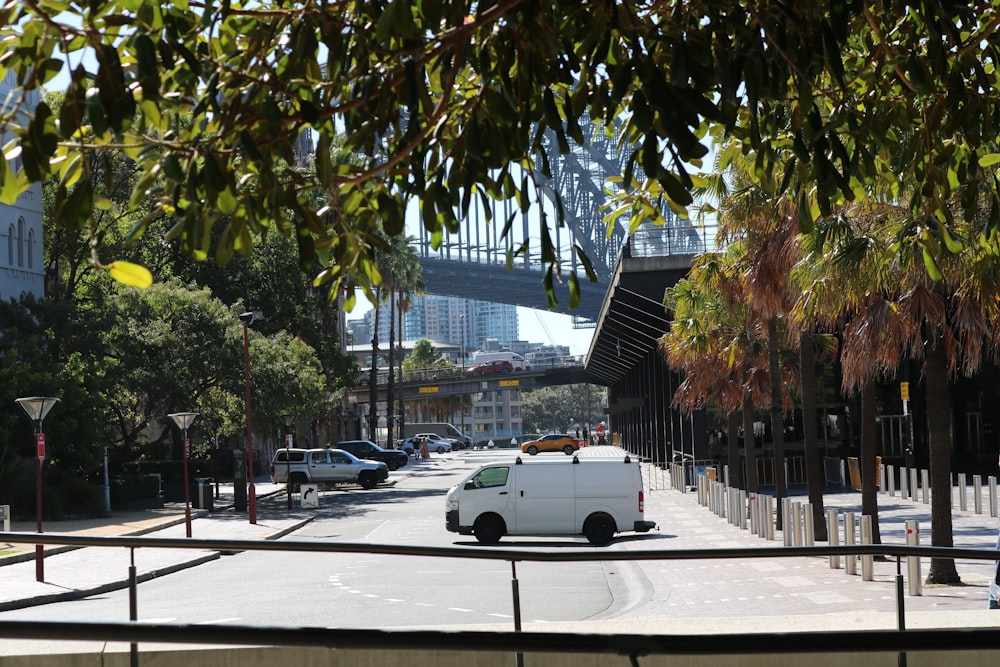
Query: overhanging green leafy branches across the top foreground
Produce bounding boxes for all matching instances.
[0,0,1000,304]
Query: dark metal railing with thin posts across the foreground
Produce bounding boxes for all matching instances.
[0,533,1000,665]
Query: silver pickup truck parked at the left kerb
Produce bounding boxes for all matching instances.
[271,448,389,489]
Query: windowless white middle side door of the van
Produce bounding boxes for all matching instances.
[508,468,577,535]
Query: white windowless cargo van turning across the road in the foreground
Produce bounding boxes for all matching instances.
[445,456,656,546]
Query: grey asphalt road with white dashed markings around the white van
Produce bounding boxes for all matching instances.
[0,451,652,628]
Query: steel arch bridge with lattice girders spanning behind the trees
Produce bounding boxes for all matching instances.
[417,127,712,328]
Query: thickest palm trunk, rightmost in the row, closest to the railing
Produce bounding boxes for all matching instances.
[924,338,962,584]
